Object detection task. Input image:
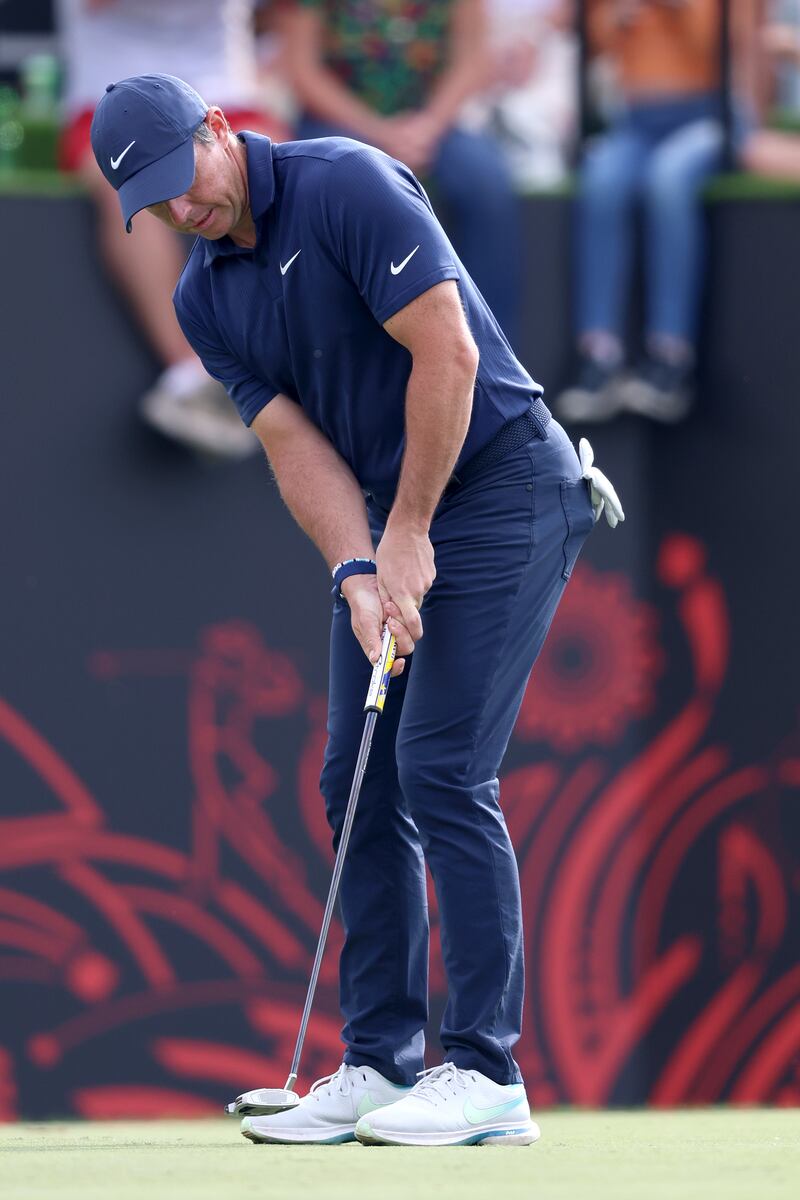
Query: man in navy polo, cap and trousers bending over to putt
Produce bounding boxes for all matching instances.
[92,76,622,1146]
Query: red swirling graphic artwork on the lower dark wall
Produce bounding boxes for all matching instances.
[0,534,800,1120]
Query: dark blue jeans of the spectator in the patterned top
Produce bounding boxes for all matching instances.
[295,115,522,353]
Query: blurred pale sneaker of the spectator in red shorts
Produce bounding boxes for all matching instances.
[140,364,259,460]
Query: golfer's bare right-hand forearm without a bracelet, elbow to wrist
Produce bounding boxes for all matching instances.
[390,346,477,532]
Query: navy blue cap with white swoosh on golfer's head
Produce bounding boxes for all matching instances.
[91,74,209,233]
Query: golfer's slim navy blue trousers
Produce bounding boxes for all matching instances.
[321,421,593,1084]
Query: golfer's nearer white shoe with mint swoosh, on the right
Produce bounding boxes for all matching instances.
[355,1062,540,1146]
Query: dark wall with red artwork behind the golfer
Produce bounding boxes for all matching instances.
[0,189,800,1117]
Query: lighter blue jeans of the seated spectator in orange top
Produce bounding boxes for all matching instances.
[576,92,723,342]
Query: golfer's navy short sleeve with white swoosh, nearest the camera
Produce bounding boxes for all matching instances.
[323,146,459,325]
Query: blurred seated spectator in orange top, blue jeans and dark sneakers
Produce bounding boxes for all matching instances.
[557,0,723,421]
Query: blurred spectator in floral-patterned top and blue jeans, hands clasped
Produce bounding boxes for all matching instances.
[287,0,522,344]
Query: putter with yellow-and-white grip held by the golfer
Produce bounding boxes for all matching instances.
[225,629,397,1117]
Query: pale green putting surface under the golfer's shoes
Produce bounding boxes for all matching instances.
[0,1109,800,1200]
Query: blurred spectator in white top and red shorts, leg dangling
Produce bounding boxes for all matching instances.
[58,0,291,458]
